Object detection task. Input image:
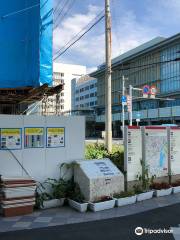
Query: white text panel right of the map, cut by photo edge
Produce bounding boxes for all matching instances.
[170,128,180,175]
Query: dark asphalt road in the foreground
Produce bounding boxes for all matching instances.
[0,204,180,240]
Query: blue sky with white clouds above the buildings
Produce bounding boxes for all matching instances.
[53,0,180,72]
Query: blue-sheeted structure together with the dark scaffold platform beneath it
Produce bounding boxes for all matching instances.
[0,0,63,115]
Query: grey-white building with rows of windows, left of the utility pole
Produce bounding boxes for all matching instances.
[72,75,97,110]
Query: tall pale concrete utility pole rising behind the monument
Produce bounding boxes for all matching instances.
[105,0,112,152]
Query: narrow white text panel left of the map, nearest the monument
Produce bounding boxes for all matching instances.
[125,127,142,181]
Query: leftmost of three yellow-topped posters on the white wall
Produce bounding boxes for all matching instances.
[1,128,22,150]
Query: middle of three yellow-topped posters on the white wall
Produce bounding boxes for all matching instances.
[24,127,44,148]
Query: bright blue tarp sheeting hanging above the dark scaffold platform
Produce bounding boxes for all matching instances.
[0,0,53,88]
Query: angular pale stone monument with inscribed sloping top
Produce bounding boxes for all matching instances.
[74,159,124,202]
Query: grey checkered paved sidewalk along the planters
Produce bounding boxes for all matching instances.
[0,193,180,232]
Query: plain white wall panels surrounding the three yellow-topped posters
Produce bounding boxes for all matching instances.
[0,115,85,181]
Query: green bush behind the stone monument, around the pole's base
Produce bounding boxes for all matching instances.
[85,143,124,172]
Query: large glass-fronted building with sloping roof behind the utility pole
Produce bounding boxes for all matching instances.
[91,34,180,137]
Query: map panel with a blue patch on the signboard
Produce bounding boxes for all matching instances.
[144,127,168,177]
